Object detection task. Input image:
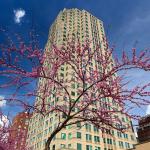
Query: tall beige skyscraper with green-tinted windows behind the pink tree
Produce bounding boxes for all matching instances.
[27,9,136,150]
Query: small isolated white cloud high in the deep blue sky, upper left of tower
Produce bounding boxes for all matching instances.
[14,8,26,23]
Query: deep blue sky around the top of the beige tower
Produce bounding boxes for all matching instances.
[0,0,150,119]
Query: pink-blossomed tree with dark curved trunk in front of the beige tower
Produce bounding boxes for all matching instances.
[0,29,150,150]
